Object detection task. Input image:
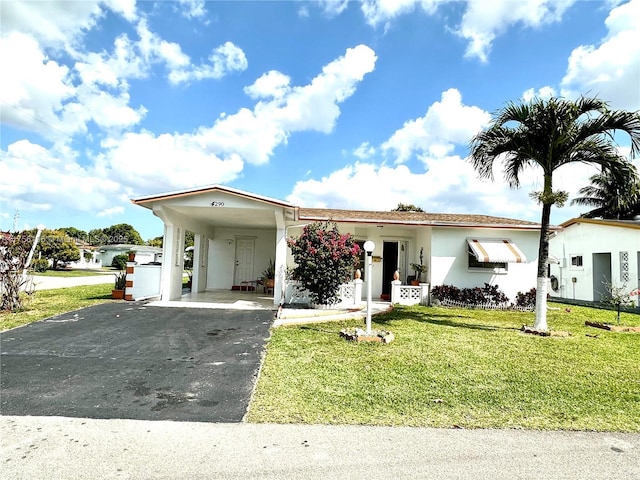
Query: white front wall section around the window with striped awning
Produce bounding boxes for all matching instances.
[430,227,540,300]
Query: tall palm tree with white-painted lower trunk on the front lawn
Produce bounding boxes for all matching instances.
[469,97,640,330]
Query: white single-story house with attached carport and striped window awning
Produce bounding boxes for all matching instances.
[132,186,540,304]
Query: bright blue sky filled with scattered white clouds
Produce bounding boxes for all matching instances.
[0,0,640,239]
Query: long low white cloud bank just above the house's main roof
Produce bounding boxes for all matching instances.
[287,156,608,224]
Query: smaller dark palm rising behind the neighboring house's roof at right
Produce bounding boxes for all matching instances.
[571,163,640,219]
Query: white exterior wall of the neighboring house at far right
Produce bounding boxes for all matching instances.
[549,223,640,302]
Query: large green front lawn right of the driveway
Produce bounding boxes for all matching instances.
[248,305,640,432]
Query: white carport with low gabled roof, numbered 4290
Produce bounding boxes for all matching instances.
[132,185,297,305]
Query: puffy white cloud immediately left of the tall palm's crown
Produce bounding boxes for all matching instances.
[380,88,491,163]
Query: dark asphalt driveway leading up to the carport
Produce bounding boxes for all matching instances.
[0,302,273,422]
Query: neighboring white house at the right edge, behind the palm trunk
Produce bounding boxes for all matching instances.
[549,218,640,302]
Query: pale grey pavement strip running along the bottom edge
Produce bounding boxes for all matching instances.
[0,417,640,480]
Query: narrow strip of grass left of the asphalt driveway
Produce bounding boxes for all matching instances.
[0,283,113,331]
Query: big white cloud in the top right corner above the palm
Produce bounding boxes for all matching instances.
[561,0,640,111]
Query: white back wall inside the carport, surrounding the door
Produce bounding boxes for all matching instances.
[207,228,276,290]
